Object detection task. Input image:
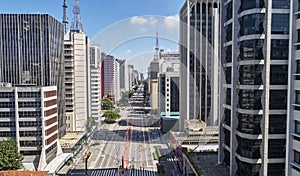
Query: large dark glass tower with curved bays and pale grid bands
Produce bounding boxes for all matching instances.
[219,0,290,176]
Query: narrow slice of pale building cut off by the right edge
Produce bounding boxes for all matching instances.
[281,0,300,176]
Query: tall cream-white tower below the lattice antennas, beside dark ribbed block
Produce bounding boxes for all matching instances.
[64,31,91,131]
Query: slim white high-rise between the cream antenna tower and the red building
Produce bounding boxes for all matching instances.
[90,44,101,119]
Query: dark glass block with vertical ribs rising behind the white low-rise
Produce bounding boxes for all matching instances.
[0,14,63,86]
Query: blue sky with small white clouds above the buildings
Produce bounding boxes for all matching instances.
[0,0,185,72]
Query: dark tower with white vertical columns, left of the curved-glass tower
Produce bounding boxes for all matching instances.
[179,0,220,130]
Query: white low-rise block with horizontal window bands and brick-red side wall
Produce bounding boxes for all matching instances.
[0,86,62,170]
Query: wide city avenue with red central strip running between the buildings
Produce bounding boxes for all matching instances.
[69,84,167,175]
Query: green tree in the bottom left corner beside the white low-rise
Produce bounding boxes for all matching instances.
[0,139,23,170]
